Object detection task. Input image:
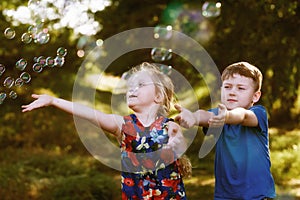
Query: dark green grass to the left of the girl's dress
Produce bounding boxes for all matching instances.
[0,148,120,200]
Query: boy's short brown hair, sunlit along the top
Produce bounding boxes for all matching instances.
[221,62,263,92]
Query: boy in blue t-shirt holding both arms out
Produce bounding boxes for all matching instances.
[175,62,276,200]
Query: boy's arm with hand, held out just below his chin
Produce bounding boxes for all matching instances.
[209,104,258,127]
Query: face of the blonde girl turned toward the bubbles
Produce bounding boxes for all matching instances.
[126,71,161,111]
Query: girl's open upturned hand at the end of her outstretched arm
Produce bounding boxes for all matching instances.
[22,94,54,112]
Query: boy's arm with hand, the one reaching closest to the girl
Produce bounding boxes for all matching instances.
[175,105,214,128]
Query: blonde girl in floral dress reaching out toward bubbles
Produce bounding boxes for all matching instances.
[22,63,191,200]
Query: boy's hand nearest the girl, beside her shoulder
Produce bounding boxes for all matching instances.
[174,104,196,128]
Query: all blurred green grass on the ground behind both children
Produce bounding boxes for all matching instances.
[0,128,300,200]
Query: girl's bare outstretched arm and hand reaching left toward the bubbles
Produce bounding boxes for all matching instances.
[22,94,123,137]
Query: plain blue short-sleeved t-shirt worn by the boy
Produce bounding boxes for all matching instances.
[204,105,276,200]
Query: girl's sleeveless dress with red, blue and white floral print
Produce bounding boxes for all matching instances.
[121,114,186,200]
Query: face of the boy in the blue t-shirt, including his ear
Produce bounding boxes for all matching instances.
[221,74,261,110]
